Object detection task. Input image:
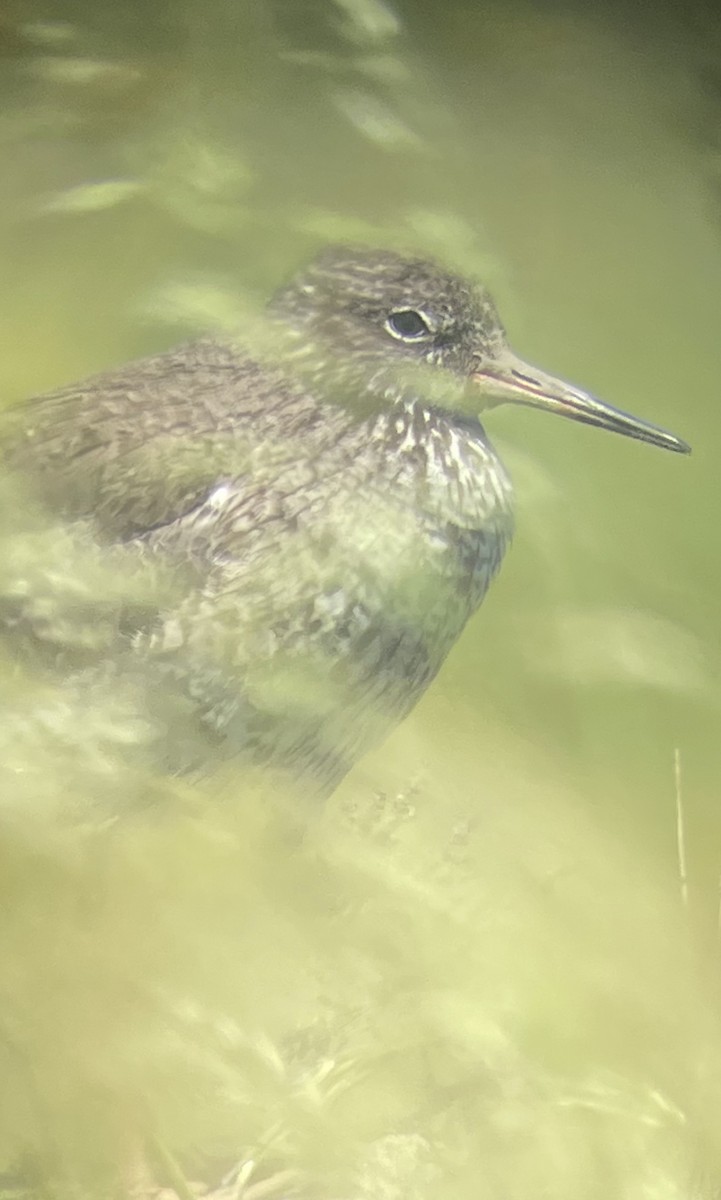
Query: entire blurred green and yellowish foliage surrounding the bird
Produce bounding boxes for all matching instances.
[0,0,721,1200]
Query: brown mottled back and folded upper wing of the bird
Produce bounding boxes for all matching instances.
[1,338,328,541]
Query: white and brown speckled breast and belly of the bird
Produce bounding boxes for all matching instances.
[140,406,512,784]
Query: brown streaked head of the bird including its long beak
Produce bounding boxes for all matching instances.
[269,246,690,454]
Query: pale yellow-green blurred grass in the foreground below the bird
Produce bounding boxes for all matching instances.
[0,713,719,1196]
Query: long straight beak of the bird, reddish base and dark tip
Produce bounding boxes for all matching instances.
[470,350,691,454]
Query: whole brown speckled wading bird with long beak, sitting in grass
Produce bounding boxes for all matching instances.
[0,245,690,796]
